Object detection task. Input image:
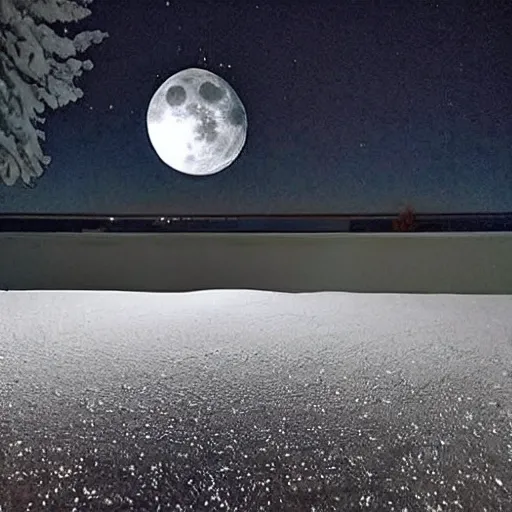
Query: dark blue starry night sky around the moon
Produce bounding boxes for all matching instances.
[0,0,512,214]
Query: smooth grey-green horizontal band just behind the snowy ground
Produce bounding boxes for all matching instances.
[0,233,512,294]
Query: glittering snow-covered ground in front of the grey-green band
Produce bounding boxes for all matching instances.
[0,290,512,512]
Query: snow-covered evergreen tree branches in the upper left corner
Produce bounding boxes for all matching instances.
[0,0,108,186]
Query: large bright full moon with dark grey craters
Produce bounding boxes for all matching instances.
[146,68,247,176]
